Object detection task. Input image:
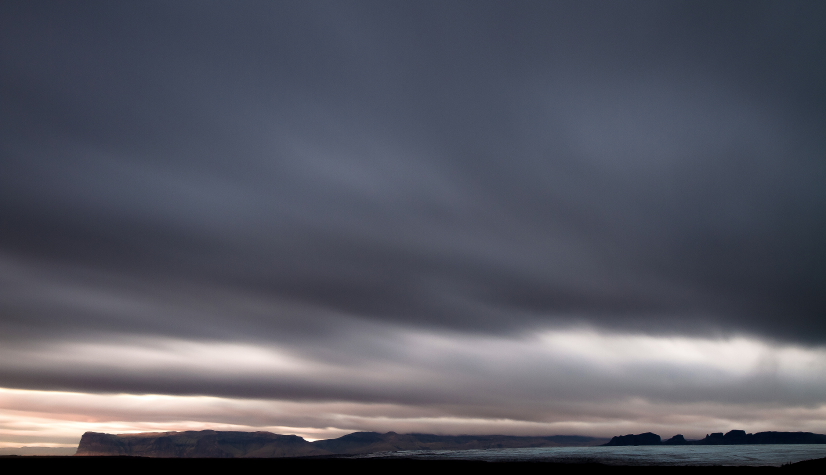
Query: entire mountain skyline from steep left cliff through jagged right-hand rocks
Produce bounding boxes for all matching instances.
[75,430,826,458]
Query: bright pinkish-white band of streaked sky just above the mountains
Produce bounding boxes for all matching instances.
[0,329,826,445]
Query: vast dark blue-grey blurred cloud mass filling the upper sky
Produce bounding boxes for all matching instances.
[0,2,826,360]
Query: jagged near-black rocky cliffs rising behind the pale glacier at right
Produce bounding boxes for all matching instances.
[605,430,826,446]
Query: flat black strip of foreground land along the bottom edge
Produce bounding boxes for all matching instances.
[0,456,826,475]
